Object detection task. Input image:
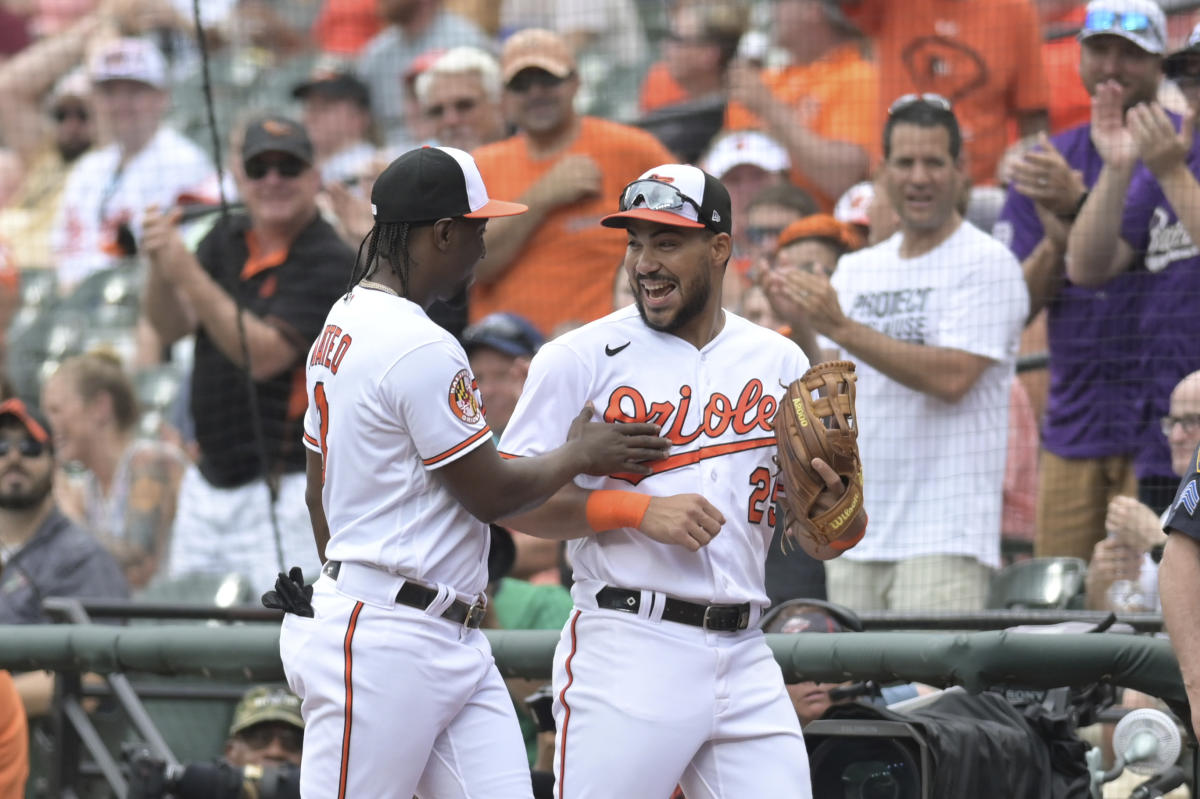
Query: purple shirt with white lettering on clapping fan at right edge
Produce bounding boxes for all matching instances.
[1121,128,1200,477]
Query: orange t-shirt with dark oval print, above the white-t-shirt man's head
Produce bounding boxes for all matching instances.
[842,0,1051,185]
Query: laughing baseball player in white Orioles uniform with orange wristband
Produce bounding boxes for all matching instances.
[500,164,841,799]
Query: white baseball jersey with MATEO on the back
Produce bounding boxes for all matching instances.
[304,287,492,596]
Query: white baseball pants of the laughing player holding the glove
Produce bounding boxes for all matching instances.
[553,602,812,799]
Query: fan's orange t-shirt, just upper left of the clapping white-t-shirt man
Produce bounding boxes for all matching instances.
[725,43,881,211]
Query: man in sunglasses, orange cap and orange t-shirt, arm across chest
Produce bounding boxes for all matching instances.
[470,28,672,335]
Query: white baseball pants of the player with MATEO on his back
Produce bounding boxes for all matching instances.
[280,565,532,799]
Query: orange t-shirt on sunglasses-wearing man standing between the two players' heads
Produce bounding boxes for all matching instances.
[470,116,674,335]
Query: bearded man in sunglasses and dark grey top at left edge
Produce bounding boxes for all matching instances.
[0,398,130,716]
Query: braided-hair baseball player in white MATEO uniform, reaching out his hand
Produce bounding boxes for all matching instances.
[278,148,667,799]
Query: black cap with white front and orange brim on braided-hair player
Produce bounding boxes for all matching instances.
[371,146,529,223]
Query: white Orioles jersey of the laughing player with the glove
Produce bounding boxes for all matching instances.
[500,306,808,605]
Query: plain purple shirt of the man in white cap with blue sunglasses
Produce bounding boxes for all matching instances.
[992,125,1142,458]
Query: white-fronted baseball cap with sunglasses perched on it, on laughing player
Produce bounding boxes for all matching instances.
[600,163,733,233]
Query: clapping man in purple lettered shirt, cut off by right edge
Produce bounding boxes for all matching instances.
[1067,14,1200,523]
